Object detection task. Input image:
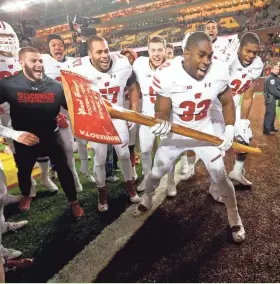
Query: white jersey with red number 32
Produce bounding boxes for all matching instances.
[153,60,229,131]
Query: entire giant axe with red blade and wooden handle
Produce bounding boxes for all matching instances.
[61,70,262,155]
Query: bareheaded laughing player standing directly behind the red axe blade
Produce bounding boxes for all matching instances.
[72,36,141,211]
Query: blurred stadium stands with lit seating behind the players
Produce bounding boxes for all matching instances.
[0,0,280,74]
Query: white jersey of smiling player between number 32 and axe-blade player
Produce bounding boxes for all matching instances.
[133,56,156,116]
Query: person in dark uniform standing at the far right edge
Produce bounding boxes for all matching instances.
[263,65,280,135]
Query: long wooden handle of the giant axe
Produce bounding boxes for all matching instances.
[104,103,262,155]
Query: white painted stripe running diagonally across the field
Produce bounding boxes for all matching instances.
[48,162,181,283]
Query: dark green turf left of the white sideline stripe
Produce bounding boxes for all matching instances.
[3,154,144,283]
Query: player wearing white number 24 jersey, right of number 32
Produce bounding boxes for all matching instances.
[210,32,264,202]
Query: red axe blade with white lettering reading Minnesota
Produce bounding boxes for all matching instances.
[61,70,122,144]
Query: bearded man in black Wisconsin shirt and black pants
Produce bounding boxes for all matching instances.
[0,47,84,218]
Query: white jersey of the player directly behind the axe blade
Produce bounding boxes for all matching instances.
[71,54,132,107]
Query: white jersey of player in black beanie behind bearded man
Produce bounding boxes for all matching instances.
[42,54,76,81]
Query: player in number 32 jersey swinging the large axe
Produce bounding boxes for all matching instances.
[134,32,245,243]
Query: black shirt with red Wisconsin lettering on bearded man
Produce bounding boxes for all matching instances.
[0,72,66,136]
